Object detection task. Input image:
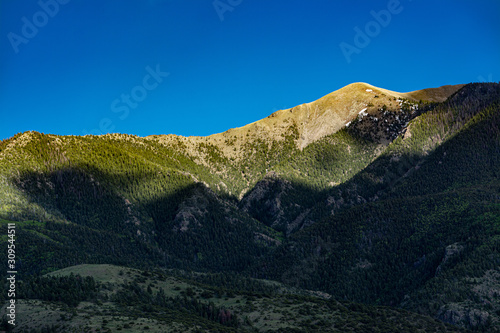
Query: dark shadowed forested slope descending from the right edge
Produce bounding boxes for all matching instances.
[261,84,500,330]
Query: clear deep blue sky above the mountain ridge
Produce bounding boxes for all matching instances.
[0,0,500,139]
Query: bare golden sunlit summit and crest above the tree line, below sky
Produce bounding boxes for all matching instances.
[151,82,464,158]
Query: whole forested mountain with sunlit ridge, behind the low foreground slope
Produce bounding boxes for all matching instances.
[0,83,500,332]
